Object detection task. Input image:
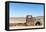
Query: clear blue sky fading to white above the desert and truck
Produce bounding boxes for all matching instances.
[9,3,44,17]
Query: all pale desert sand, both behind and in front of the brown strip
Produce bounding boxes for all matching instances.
[9,18,43,29]
